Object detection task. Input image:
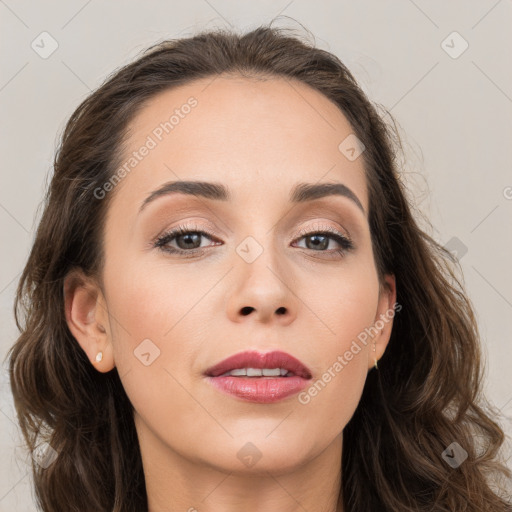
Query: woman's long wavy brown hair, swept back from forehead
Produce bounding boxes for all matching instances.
[8,26,512,512]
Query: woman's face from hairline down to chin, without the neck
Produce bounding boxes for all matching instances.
[76,77,396,471]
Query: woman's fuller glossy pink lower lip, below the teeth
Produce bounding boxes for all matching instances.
[204,376,307,404]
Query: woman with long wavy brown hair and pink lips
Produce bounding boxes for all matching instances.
[5,27,511,512]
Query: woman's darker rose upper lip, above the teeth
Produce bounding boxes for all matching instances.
[205,350,311,379]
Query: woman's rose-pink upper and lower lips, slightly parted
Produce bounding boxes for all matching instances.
[204,351,311,403]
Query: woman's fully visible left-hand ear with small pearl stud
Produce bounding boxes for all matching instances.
[64,270,115,373]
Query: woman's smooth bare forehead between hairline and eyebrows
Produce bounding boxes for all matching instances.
[115,76,368,211]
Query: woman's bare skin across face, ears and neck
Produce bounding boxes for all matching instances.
[65,77,396,512]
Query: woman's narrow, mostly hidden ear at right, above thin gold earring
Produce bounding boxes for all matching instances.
[368,274,402,369]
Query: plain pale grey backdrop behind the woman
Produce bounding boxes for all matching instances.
[0,0,512,512]
